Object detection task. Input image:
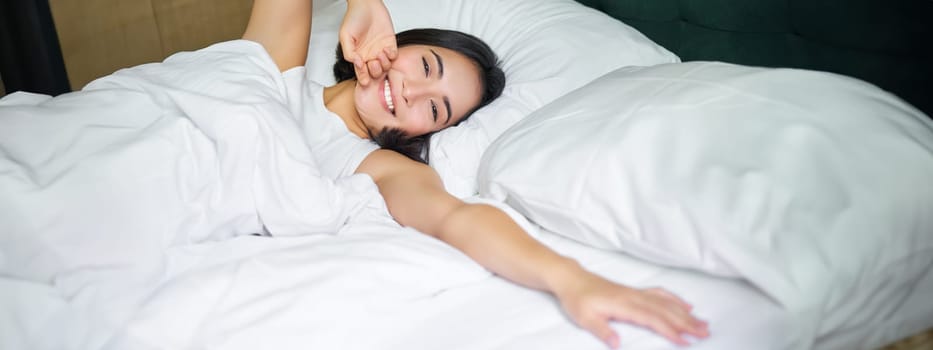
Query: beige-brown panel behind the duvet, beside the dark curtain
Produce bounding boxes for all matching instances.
[49,0,253,90]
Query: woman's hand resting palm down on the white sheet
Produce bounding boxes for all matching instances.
[555,272,709,349]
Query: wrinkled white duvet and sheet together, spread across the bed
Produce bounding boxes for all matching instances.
[0,37,933,349]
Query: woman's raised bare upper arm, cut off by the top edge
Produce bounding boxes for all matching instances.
[243,0,311,71]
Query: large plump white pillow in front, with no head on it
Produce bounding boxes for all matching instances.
[479,62,933,332]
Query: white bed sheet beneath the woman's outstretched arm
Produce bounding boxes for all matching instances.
[0,216,800,349]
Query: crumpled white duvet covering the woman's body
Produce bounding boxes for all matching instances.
[0,41,416,348]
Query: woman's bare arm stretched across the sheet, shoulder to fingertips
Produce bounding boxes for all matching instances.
[357,150,708,348]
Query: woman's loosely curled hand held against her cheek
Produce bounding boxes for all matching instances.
[340,0,398,85]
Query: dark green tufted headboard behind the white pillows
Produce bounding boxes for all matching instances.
[577,0,933,117]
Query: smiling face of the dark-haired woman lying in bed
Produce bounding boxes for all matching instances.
[354,45,483,137]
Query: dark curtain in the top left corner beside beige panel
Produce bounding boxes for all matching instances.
[0,0,71,95]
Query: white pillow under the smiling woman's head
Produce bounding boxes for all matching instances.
[307,0,679,198]
